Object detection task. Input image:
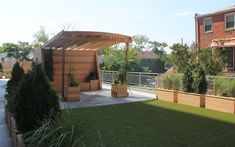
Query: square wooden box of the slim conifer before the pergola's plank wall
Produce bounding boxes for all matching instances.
[64,86,80,101]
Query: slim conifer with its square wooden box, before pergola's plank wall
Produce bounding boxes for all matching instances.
[64,65,80,101]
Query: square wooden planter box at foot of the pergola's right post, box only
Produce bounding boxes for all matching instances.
[111,84,129,97]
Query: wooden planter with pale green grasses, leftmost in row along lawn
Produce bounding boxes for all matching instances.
[156,72,181,103]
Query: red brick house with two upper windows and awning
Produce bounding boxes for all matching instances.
[195,5,235,70]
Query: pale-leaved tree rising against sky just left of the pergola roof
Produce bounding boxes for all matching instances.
[32,26,49,50]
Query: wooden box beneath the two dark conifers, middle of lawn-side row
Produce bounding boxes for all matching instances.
[178,91,205,107]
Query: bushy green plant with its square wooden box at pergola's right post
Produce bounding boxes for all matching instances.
[111,68,129,97]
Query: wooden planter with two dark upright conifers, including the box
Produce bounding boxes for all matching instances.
[178,66,207,107]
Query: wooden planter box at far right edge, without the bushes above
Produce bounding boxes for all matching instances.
[205,95,235,113]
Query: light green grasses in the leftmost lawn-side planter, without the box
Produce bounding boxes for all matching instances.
[163,72,182,90]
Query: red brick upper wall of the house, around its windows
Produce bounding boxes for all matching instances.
[198,11,235,48]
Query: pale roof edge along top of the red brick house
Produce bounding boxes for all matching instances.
[195,5,235,18]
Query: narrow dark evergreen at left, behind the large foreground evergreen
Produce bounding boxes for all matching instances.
[5,62,24,113]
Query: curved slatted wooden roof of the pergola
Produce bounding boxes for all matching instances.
[43,31,133,51]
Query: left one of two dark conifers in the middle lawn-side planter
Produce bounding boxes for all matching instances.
[182,65,194,92]
